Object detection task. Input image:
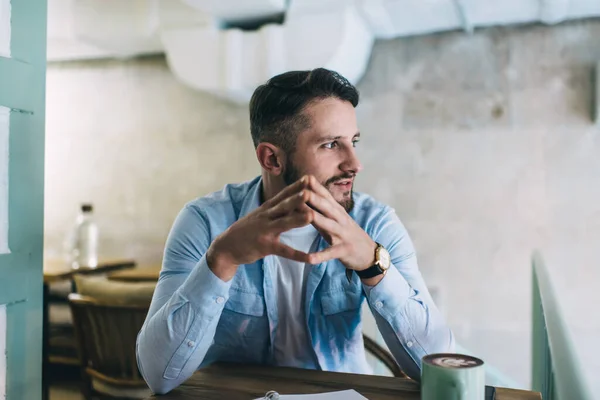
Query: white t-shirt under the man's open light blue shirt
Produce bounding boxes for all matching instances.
[273,225,318,369]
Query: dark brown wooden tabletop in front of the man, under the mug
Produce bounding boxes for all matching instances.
[147,363,541,400]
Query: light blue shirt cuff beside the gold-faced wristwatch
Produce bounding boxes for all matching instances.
[363,265,411,315]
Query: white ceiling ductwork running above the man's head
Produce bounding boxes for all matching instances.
[48,0,600,102]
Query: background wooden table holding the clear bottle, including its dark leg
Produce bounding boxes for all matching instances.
[42,259,135,400]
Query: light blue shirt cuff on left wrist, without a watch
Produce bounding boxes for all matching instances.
[179,255,231,315]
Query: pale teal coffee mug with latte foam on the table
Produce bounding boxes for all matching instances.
[421,353,485,400]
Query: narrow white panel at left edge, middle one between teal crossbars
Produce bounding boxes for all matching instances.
[0,108,10,254]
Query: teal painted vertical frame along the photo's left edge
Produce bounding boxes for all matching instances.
[0,0,47,400]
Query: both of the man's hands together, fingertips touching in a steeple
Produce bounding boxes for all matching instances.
[207,176,377,280]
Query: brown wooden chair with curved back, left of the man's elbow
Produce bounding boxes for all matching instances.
[69,293,151,400]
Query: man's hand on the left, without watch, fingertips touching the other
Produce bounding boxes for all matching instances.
[206,177,314,281]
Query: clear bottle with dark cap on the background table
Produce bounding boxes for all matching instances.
[67,204,98,268]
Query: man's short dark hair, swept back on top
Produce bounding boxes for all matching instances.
[250,68,359,153]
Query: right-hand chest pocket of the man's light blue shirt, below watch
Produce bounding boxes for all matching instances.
[321,291,364,340]
